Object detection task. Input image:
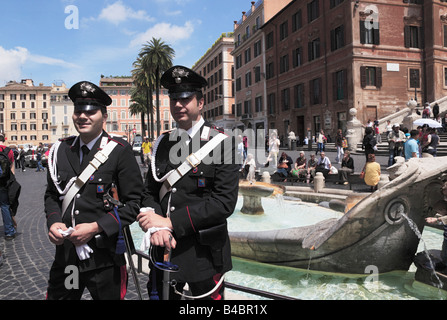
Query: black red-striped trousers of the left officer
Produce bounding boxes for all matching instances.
[47,264,128,300]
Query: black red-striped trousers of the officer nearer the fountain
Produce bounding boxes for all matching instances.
[147,268,225,300]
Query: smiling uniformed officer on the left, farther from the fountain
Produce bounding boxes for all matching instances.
[45,81,143,300]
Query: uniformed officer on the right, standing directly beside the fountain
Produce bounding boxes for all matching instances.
[137,66,239,299]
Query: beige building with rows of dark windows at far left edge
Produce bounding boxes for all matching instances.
[0,79,52,146]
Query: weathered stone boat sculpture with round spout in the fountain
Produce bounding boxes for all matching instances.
[230,157,447,274]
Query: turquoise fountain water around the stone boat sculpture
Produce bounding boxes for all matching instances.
[131,198,447,300]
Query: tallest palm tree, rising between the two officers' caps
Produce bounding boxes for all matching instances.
[139,38,175,137]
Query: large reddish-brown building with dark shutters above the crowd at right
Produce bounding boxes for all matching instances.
[262,0,447,142]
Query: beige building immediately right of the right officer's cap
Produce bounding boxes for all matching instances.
[192,33,238,129]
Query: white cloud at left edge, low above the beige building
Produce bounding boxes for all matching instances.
[0,46,79,86]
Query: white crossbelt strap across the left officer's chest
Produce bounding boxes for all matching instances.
[62,140,118,217]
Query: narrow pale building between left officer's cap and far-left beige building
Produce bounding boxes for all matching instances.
[49,82,77,143]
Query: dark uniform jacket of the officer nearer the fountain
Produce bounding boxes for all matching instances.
[142,123,239,282]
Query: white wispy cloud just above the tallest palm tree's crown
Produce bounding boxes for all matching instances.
[130,21,194,47]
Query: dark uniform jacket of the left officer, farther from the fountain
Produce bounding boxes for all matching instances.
[45,132,143,271]
